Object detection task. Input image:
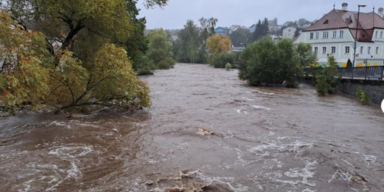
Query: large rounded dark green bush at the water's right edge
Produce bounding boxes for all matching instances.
[238,37,316,87]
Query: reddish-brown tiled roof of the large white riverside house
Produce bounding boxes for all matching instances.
[305,9,384,41]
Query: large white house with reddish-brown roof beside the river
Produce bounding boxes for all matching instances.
[295,3,384,67]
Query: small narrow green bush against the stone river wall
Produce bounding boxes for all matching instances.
[315,56,340,95]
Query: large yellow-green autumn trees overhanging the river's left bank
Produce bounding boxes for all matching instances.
[0,0,170,112]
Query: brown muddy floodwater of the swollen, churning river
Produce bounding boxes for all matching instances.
[0,64,384,192]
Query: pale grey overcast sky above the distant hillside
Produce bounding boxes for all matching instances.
[138,0,384,29]
